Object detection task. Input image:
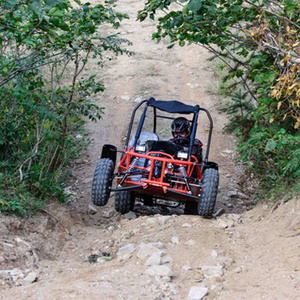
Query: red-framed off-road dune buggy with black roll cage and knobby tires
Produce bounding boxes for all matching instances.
[92,98,219,217]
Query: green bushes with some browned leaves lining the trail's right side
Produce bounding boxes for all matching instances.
[138,0,300,198]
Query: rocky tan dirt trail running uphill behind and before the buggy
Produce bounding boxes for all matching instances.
[0,0,300,300]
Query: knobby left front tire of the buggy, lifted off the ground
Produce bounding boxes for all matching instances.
[92,158,114,206]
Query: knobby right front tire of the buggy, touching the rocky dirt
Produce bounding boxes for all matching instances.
[198,169,219,218]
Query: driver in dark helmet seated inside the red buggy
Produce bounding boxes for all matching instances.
[170,117,203,162]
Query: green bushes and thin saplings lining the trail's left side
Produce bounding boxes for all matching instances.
[0,0,129,215]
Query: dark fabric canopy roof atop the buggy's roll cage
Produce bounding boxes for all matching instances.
[148,98,200,114]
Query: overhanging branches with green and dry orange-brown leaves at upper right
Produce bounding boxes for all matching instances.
[138,0,300,128]
